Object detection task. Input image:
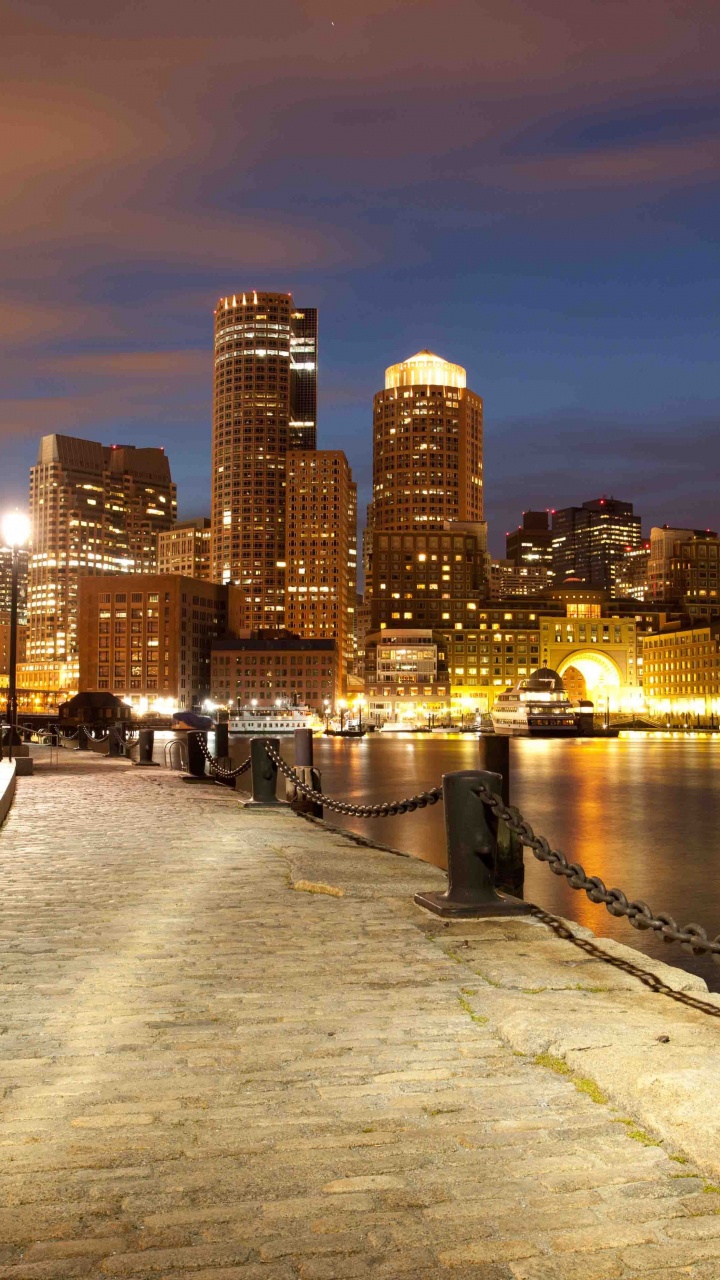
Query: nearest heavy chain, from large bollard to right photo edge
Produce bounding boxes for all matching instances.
[477,782,720,965]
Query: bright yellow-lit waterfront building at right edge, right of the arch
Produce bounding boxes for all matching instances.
[643,621,720,716]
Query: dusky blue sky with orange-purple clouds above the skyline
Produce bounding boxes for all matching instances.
[0,0,720,554]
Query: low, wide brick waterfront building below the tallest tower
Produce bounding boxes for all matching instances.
[211,628,335,714]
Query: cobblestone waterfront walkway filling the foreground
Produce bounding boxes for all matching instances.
[0,754,720,1280]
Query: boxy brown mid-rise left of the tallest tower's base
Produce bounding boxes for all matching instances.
[78,573,228,708]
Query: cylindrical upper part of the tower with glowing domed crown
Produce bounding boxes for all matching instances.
[373,351,483,532]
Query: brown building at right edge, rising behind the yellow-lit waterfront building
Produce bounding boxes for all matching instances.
[647,525,720,616]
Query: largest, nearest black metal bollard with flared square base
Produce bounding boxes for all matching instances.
[415,769,533,918]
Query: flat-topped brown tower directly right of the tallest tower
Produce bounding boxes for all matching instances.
[286,449,357,682]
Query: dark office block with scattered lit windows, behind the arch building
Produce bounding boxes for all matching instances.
[552,498,642,591]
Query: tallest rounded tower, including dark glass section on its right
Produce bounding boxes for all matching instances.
[211,291,316,628]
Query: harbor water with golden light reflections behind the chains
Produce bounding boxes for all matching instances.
[226,733,720,989]
